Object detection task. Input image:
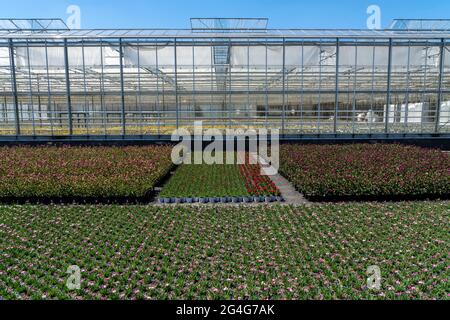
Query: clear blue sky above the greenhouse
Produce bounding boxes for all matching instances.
[0,0,450,28]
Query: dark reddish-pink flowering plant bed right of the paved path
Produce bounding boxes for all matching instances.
[280,144,450,201]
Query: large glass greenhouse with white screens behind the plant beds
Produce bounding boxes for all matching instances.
[0,18,450,140]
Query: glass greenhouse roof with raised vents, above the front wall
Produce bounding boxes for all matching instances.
[0,18,450,39]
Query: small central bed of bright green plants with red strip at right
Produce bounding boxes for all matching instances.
[159,153,280,202]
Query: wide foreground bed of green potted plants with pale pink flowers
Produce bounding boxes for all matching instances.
[0,201,450,299]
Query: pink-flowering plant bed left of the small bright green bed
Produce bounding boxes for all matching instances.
[0,146,172,198]
